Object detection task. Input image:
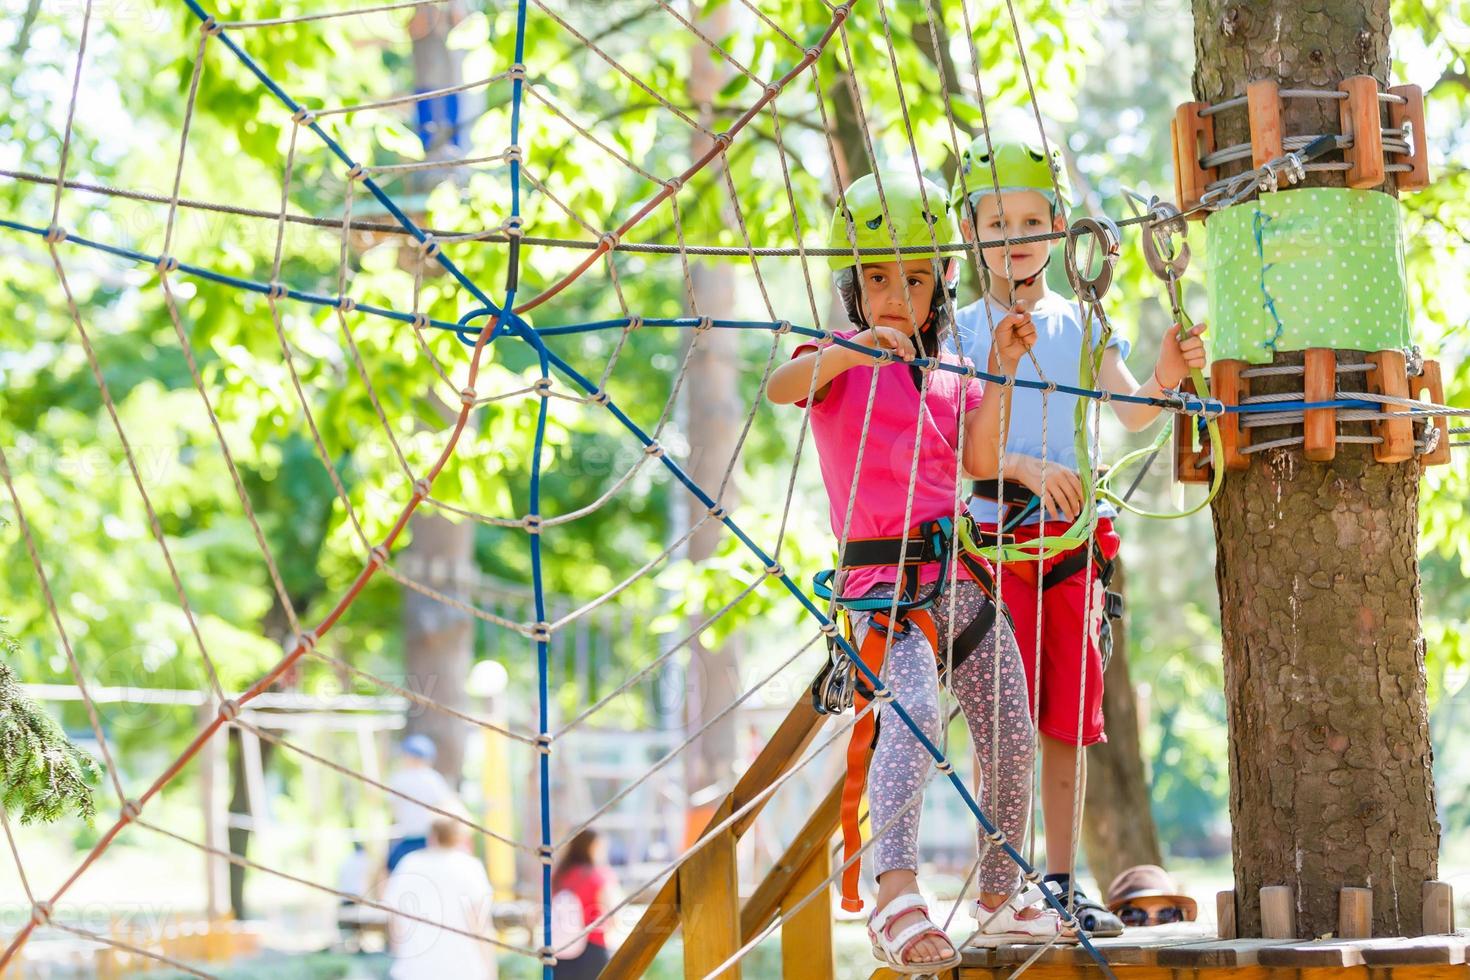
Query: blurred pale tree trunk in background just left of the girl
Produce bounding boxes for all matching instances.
[682,3,744,801]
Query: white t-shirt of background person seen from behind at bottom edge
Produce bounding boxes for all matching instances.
[382,846,497,980]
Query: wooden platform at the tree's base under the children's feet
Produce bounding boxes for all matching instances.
[873,923,1470,980]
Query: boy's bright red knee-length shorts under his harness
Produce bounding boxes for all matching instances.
[982,517,1120,745]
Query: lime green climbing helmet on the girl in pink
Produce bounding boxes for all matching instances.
[828,172,960,272]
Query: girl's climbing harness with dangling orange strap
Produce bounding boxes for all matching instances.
[811,514,1003,912]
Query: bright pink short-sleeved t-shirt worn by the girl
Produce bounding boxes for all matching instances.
[792,329,983,597]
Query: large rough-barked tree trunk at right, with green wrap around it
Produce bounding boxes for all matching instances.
[1194,0,1439,937]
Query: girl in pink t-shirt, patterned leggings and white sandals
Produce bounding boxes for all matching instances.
[767,173,1069,974]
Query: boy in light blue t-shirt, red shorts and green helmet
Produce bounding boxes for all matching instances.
[950,134,1205,934]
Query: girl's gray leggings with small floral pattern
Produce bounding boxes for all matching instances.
[853,574,1035,893]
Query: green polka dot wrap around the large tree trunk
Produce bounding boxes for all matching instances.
[1205,187,1410,364]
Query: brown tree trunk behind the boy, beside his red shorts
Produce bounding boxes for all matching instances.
[1082,558,1164,889]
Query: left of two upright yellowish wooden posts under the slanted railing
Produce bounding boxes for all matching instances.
[675,827,741,980]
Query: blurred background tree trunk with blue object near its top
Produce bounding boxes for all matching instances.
[403,1,475,786]
